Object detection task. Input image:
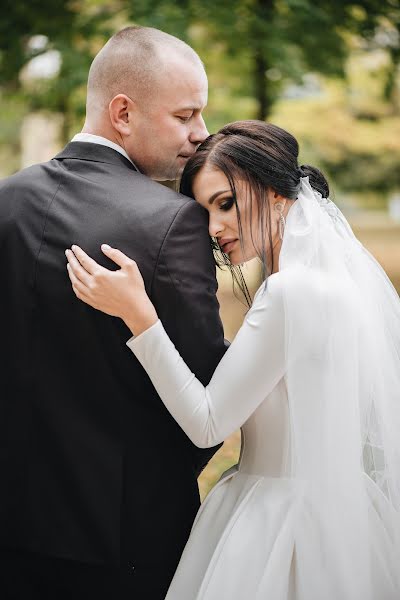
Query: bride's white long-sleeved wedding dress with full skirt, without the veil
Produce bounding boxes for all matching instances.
[128,178,400,600]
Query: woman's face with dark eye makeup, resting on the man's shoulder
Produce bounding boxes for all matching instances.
[193,165,278,265]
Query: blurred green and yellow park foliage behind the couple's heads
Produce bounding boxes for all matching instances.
[0,0,400,197]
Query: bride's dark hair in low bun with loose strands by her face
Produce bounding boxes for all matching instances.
[180,120,329,305]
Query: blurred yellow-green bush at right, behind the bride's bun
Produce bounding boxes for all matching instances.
[271,80,400,193]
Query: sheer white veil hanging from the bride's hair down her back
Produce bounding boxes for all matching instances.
[280,177,400,600]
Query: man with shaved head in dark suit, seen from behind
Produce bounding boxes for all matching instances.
[0,27,224,600]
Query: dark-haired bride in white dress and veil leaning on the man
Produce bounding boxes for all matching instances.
[67,121,400,600]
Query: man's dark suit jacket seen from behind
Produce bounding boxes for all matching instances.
[0,142,225,576]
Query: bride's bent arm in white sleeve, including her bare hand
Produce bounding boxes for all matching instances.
[66,244,285,448]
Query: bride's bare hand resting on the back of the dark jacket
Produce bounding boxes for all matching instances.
[65,244,158,335]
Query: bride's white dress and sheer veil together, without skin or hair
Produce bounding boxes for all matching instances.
[128,178,400,600]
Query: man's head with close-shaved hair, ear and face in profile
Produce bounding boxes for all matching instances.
[82,27,209,180]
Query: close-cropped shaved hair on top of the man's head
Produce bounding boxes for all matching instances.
[87,27,203,113]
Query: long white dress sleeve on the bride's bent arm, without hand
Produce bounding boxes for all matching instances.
[127,274,285,448]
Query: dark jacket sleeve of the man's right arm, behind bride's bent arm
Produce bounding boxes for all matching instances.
[150,200,226,474]
